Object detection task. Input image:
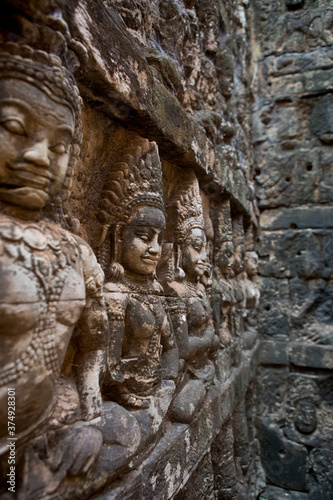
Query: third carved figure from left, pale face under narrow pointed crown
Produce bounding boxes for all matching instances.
[163,172,220,423]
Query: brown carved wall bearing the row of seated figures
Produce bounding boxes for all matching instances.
[0,0,263,500]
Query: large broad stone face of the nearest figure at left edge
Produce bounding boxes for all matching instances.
[0,79,74,210]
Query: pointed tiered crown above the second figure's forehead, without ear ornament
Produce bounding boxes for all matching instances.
[98,138,164,226]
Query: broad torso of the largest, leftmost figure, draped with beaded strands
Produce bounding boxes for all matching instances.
[0,215,92,442]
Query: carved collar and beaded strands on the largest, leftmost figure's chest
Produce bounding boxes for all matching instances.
[0,216,78,385]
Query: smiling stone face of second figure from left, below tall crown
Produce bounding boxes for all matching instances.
[120,207,165,275]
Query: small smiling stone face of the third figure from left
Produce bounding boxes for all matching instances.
[182,227,207,281]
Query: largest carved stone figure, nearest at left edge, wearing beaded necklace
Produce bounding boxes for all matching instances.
[0,38,106,498]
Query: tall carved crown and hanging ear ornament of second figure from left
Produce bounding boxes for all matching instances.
[97,137,164,279]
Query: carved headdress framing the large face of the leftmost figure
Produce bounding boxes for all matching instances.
[0,13,88,217]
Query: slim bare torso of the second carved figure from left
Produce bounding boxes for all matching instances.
[105,283,174,395]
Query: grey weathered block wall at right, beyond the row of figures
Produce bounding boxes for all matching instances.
[253,0,333,500]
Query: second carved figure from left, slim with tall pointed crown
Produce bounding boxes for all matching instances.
[99,138,178,446]
